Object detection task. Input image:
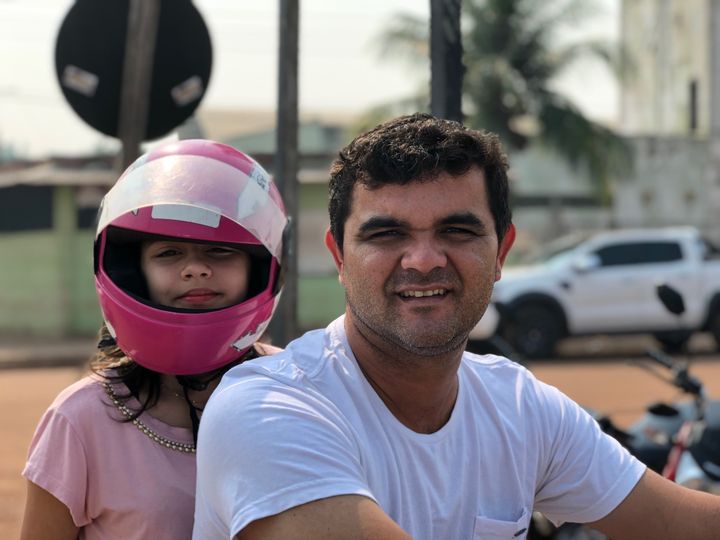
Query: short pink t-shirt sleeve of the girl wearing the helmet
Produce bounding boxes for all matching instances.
[22,407,90,527]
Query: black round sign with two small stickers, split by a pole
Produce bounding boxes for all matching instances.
[55,0,212,140]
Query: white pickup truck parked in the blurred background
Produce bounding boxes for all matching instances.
[471,227,720,358]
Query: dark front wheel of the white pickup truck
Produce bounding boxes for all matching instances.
[507,304,563,358]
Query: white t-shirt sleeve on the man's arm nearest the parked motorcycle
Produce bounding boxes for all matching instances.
[535,381,645,523]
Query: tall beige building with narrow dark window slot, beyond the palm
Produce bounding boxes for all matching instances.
[620,0,714,136]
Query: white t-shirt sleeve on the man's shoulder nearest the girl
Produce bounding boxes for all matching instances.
[193,376,374,539]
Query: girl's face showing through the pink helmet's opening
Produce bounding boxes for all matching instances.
[140,240,250,309]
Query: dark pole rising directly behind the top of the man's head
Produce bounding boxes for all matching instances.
[430,0,465,122]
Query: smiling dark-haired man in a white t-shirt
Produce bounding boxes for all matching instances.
[194,114,720,540]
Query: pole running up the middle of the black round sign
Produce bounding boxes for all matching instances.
[118,0,161,170]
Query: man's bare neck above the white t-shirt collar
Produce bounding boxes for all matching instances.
[345,317,462,433]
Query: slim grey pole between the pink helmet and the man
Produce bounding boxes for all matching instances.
[270,0,300,346]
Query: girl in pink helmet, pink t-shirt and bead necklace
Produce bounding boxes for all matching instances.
[21,140,288,540]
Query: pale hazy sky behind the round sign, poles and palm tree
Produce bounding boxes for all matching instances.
[0,0,619,157]
